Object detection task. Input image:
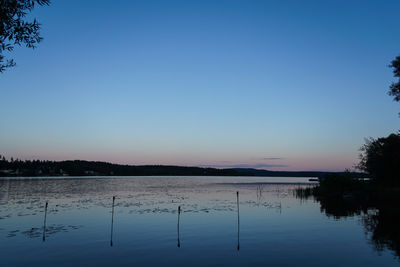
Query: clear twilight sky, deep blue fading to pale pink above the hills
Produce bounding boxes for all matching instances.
[0,0,400,171]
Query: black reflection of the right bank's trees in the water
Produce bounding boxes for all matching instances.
[297,193,400,259]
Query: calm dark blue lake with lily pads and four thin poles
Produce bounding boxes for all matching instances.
[0,177,400,266]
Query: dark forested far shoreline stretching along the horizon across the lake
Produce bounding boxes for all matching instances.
[0,158,366,178]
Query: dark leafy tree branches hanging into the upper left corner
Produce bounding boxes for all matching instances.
[0,0,50,73]
